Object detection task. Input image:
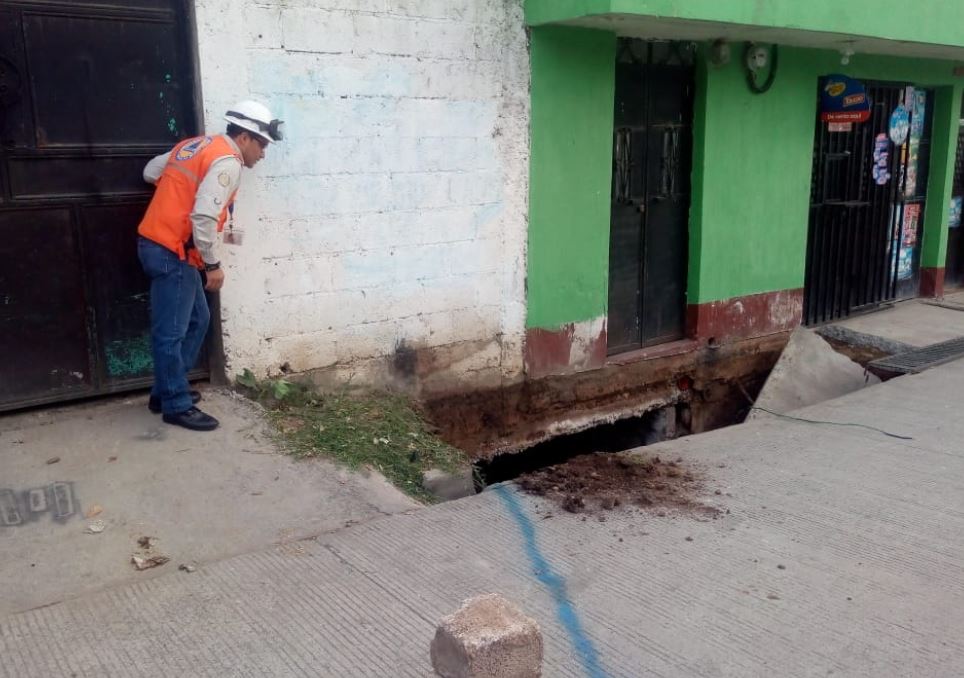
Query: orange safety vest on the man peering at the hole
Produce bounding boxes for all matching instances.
[137,136,244,268]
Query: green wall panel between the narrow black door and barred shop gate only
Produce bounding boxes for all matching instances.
[687,45,817,304]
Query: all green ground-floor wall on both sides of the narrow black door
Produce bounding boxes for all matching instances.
[527,27,961,329]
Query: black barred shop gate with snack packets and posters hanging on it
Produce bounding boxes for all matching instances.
[804,83,932,325]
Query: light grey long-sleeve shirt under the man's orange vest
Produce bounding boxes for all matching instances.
[144,136,247,264]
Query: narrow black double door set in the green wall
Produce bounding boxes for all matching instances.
[608,39,693,354]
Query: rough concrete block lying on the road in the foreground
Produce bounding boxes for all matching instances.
[431,593,542,678]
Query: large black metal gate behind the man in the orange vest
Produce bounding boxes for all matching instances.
[0,0,197,409]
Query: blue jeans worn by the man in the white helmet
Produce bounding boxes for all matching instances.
[137,237,211,414]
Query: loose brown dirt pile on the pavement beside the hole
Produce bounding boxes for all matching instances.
[516,453,717,513]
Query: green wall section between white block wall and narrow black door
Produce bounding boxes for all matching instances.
[527,27,616,328]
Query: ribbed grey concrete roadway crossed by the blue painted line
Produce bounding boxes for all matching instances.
[0,361,964,678]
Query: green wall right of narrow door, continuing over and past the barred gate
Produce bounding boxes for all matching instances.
[688,48,960,304]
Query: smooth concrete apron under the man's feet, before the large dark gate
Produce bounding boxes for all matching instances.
[0,389,419,616]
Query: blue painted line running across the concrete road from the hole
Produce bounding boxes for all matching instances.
[492,485,606,678]
